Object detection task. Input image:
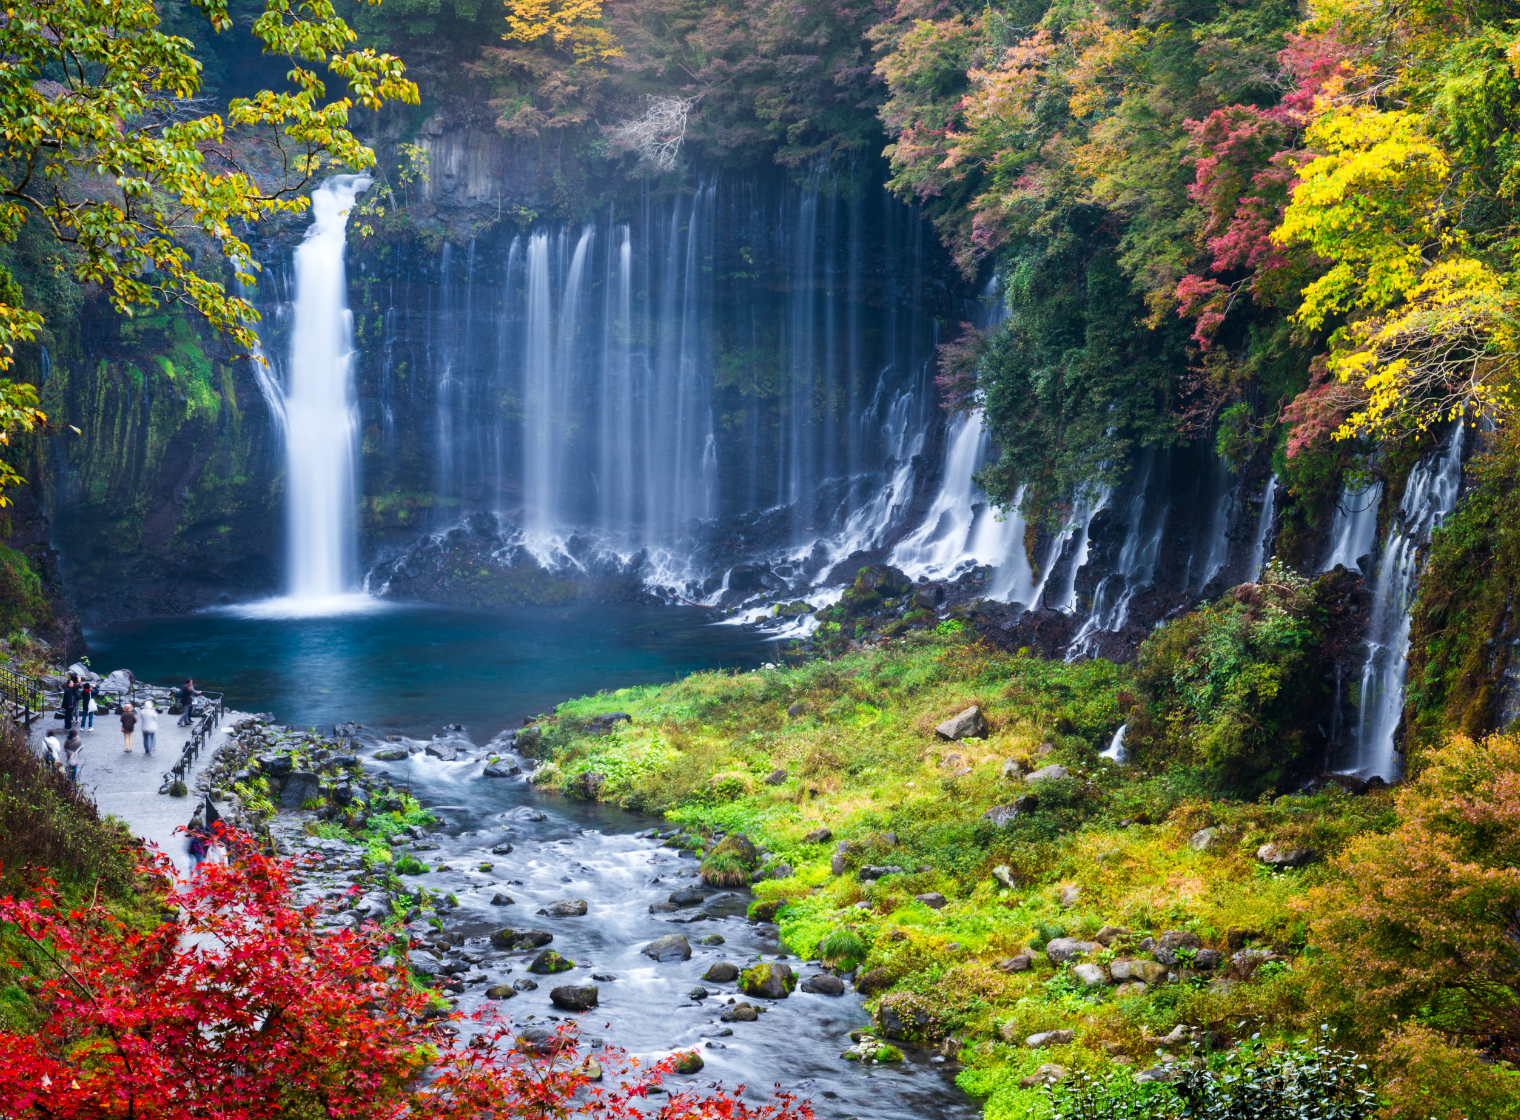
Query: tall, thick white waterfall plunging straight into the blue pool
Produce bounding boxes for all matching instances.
[242,175,374,617]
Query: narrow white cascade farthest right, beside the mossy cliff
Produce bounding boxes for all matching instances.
[1338,421,1464,780]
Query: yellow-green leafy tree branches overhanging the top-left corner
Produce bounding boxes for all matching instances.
[0,0,418,498]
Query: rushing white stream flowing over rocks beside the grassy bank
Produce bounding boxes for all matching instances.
[322,751,980,1120]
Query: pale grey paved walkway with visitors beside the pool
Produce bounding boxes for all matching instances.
[32,699,242,874]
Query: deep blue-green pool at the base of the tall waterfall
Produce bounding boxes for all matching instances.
[85,603,772,743]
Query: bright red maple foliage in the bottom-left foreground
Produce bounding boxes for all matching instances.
[0,833,812,1120]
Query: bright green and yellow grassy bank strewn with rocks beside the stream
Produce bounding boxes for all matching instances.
[523,616,1520,1117]
